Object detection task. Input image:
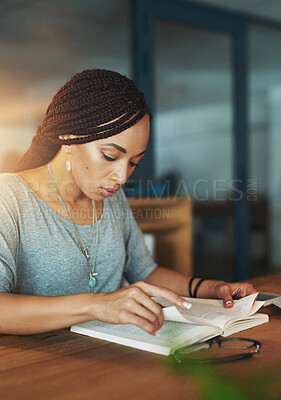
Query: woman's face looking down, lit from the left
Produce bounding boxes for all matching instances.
[67,114,150,201]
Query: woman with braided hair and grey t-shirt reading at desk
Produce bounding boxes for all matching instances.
[0,70,254,334]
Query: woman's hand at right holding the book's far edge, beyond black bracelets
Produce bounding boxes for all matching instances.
[215,282,257,308]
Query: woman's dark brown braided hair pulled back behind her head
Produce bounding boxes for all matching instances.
[14,69,151,172]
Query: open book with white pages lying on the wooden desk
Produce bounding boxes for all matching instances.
[70,294,269,355]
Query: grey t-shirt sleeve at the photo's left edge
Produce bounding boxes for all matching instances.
[0,184,19,293]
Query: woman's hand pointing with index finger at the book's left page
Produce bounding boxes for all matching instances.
[93,281,190,335]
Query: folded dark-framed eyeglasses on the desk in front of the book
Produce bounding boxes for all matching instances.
[173,338,261,364]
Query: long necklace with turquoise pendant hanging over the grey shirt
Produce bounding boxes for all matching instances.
[47,164,99,291]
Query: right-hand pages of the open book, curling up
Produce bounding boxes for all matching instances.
[157,294,263,330]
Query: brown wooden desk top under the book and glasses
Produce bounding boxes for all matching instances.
[0,274,281,400]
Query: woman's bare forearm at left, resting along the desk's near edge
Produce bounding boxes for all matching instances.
[0,293,95,335]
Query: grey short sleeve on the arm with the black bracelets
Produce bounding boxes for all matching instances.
[118,191,157,284]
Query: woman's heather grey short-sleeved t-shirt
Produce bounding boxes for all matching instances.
[0,174,156,296]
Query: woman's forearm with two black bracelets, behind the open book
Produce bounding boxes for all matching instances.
[145,267,222,298]
